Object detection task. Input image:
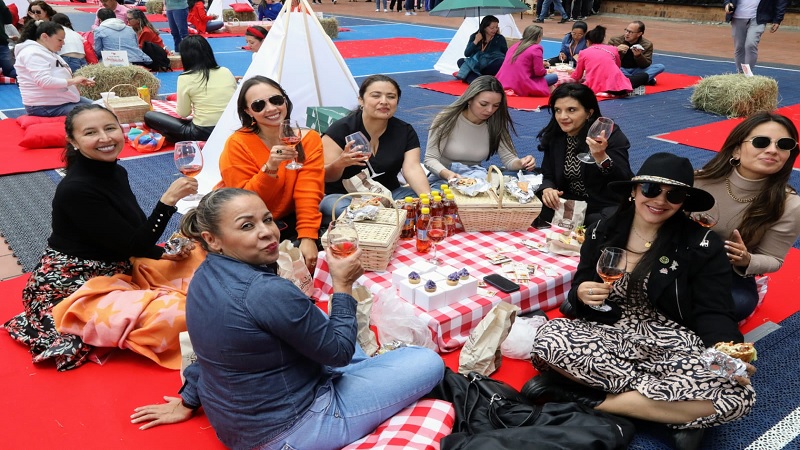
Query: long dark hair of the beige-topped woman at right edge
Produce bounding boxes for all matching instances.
[695,112,800,247]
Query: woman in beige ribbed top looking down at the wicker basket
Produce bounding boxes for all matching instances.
[424,75,536,185]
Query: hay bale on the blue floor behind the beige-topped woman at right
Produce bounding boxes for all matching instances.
[691,74,778,117]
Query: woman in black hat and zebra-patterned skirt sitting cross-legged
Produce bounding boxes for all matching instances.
[522,153,755,448]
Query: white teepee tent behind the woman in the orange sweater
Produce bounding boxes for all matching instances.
[178,0,358,212]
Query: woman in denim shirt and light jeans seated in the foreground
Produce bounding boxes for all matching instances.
[132,188,444,450]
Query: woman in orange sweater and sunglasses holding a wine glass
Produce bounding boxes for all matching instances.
[219,76,325,273]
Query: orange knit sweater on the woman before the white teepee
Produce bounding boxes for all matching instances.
[219,130,325,239]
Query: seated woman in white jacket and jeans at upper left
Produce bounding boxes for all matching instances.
[14,20,94,117]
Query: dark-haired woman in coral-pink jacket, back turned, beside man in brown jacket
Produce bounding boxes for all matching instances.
[572,25,648,95]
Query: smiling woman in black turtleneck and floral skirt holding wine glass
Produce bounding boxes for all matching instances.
[4,104,197,371]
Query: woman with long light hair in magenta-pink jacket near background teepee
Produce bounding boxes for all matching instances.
[497,25,558,97]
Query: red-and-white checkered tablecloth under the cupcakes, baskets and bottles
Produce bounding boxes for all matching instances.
[314,229,578,352]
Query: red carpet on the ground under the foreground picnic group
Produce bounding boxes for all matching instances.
[0,249,800,450]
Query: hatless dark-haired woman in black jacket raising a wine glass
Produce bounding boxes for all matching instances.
[534,83,633,226]
